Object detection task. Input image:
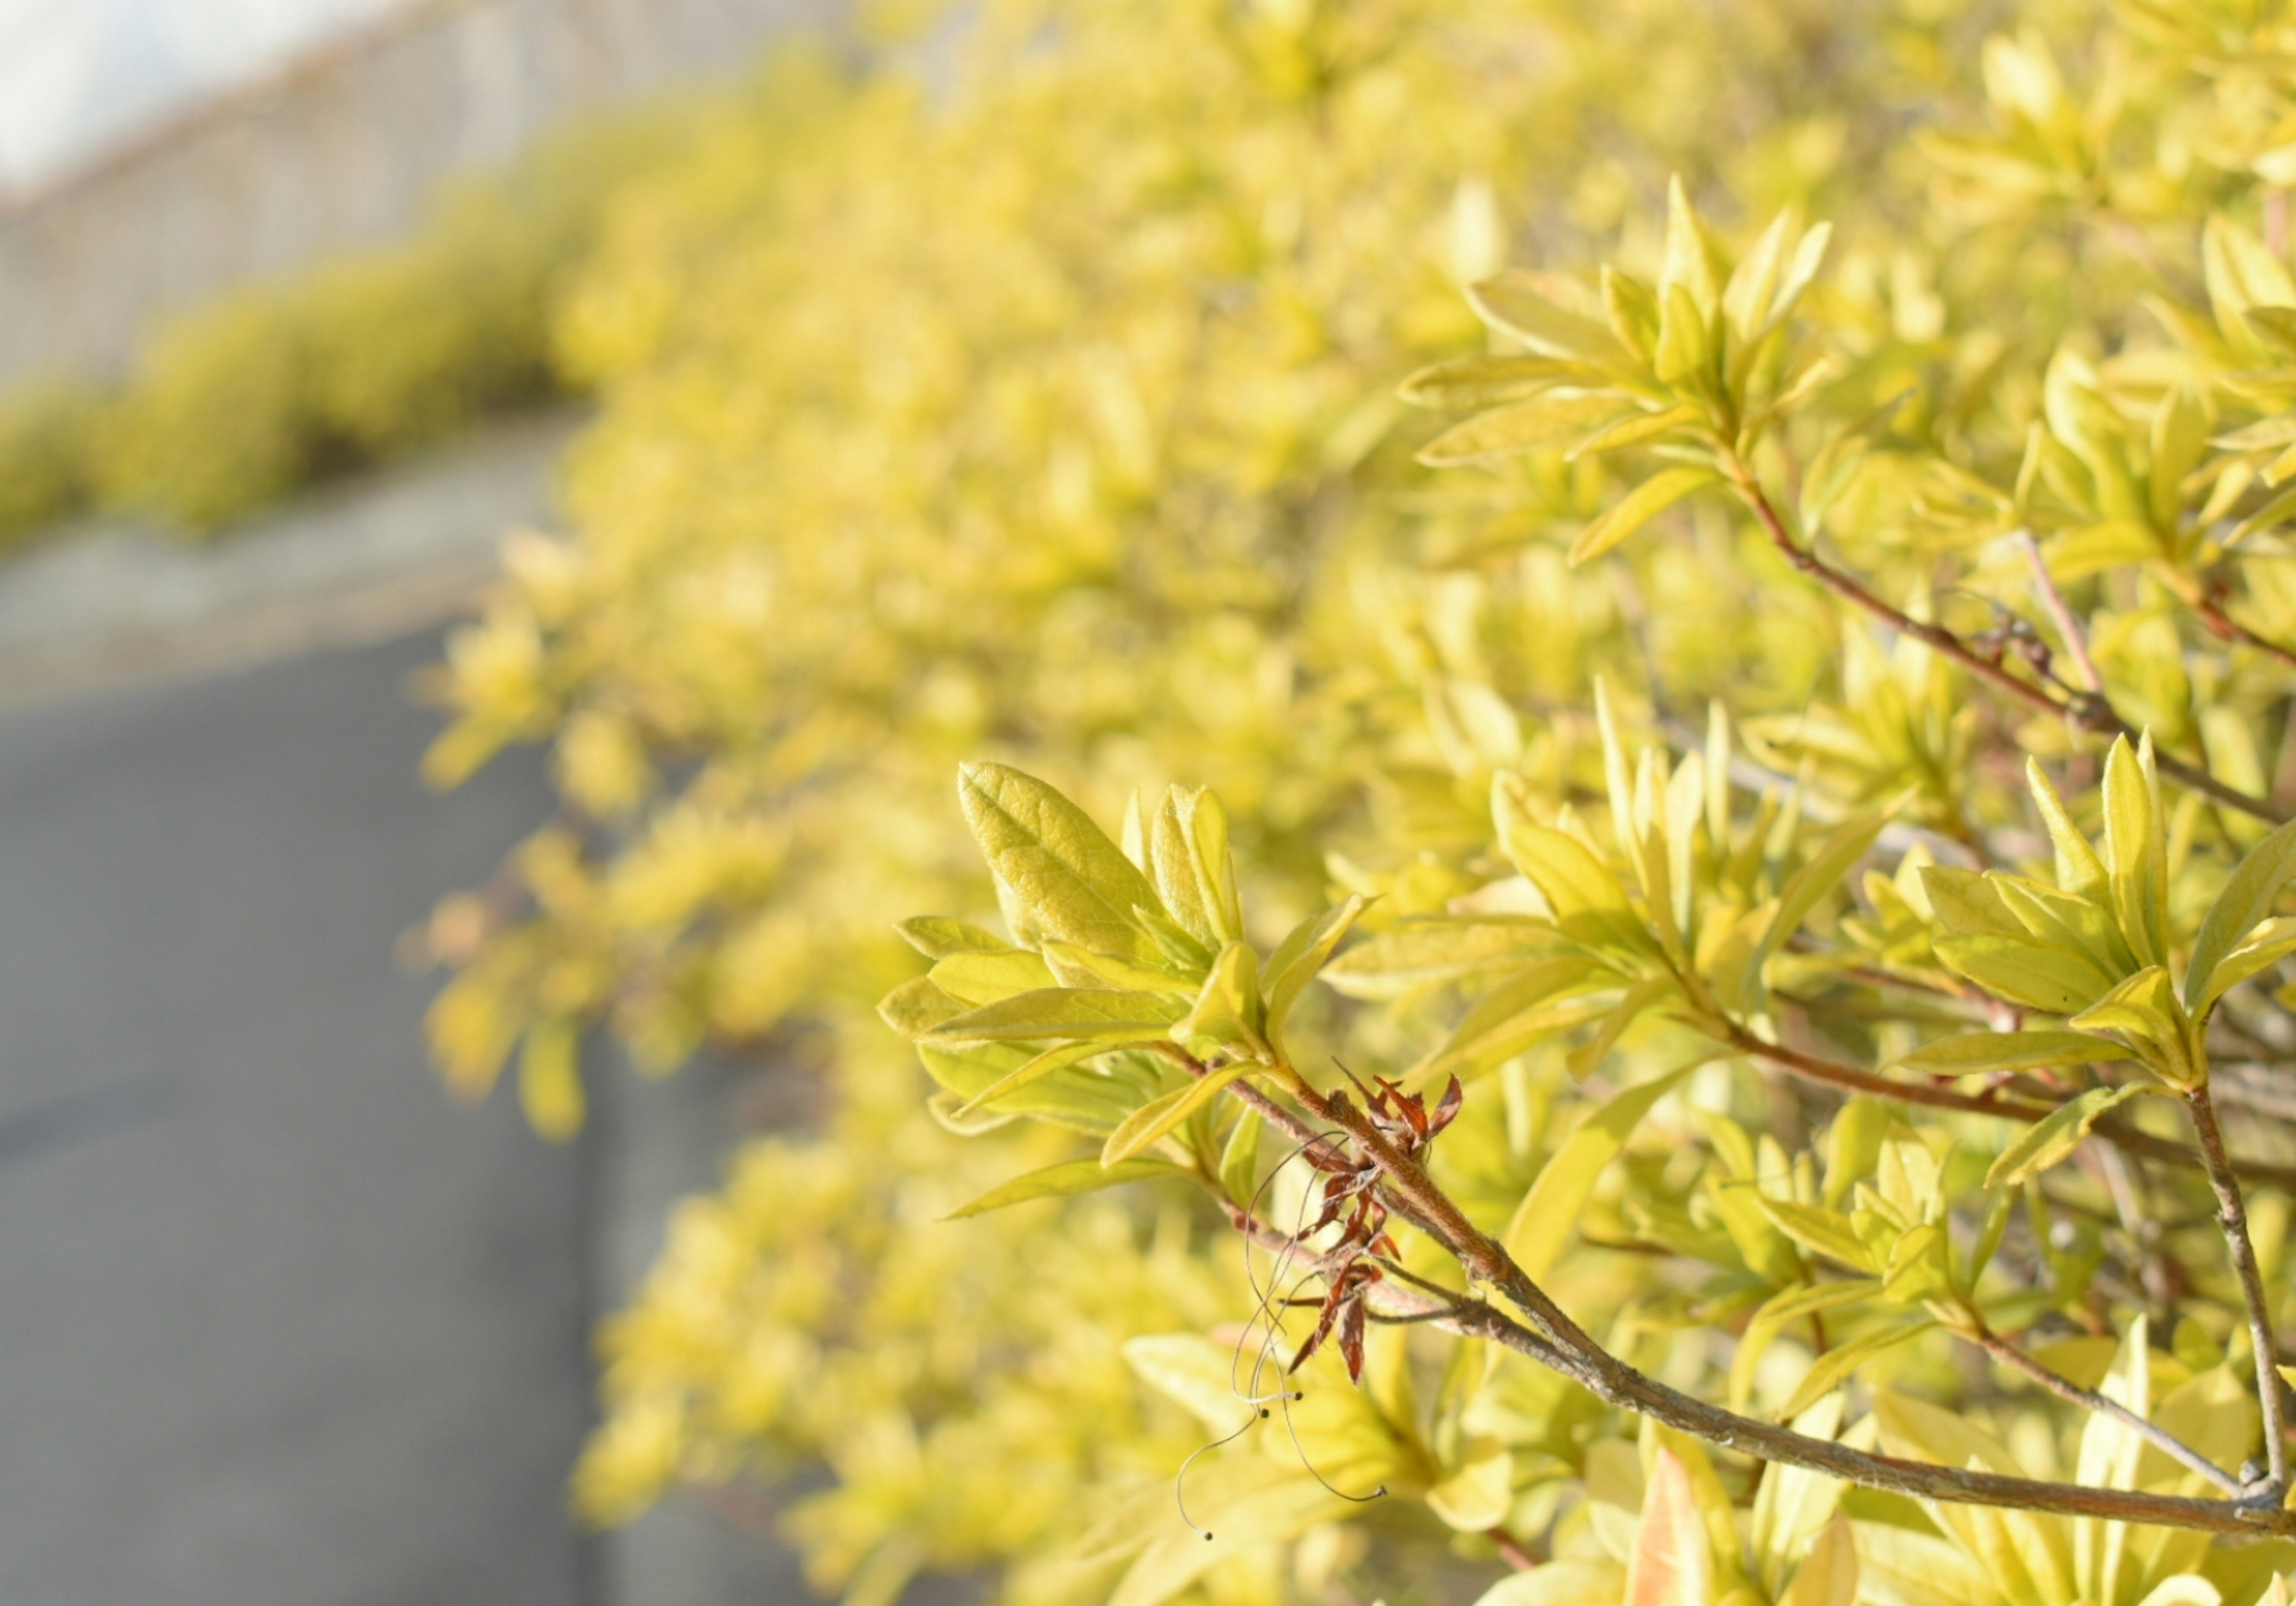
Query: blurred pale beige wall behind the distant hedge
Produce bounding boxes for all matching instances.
[0,0,842,381]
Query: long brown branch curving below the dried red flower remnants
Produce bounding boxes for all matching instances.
[1231,1066,2296,1535]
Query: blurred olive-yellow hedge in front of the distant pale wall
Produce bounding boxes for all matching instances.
[0,106,698,542]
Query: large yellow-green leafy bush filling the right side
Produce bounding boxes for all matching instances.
[432,0,2296,1606]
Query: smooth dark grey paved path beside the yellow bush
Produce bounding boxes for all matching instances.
[0,634,597,1606]
